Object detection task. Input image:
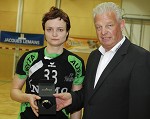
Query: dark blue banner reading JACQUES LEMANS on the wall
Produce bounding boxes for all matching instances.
[0,31,44,46]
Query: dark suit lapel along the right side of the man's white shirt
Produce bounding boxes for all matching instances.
[90,40,131,98]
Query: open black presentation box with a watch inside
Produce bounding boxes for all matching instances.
[38,80,56,115]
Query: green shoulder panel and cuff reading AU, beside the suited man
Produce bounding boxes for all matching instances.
[68,55,84,85]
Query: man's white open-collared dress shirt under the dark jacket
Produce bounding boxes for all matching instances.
[94,37,125,88]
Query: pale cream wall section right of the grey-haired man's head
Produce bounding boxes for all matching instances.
[122,0,150,51]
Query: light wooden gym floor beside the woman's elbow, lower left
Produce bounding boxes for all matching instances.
[0,79,20,119]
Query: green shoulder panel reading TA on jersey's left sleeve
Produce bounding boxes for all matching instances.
[23,52,38,75]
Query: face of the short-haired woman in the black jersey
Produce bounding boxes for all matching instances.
[44,18,68,47]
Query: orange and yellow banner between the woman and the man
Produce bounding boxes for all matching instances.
[65,37,100,53]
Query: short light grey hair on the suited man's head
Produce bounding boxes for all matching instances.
[93,2,122,20]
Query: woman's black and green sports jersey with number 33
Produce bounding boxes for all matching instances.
[16,47,85,119]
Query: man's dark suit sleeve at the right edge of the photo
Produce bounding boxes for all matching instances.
[129,50,150,119]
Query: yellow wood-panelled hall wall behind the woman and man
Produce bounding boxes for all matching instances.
[0,0,121,80]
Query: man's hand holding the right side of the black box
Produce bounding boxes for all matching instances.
[53,93,72,111]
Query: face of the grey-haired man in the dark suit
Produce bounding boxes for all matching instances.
[94,12,124,51]
